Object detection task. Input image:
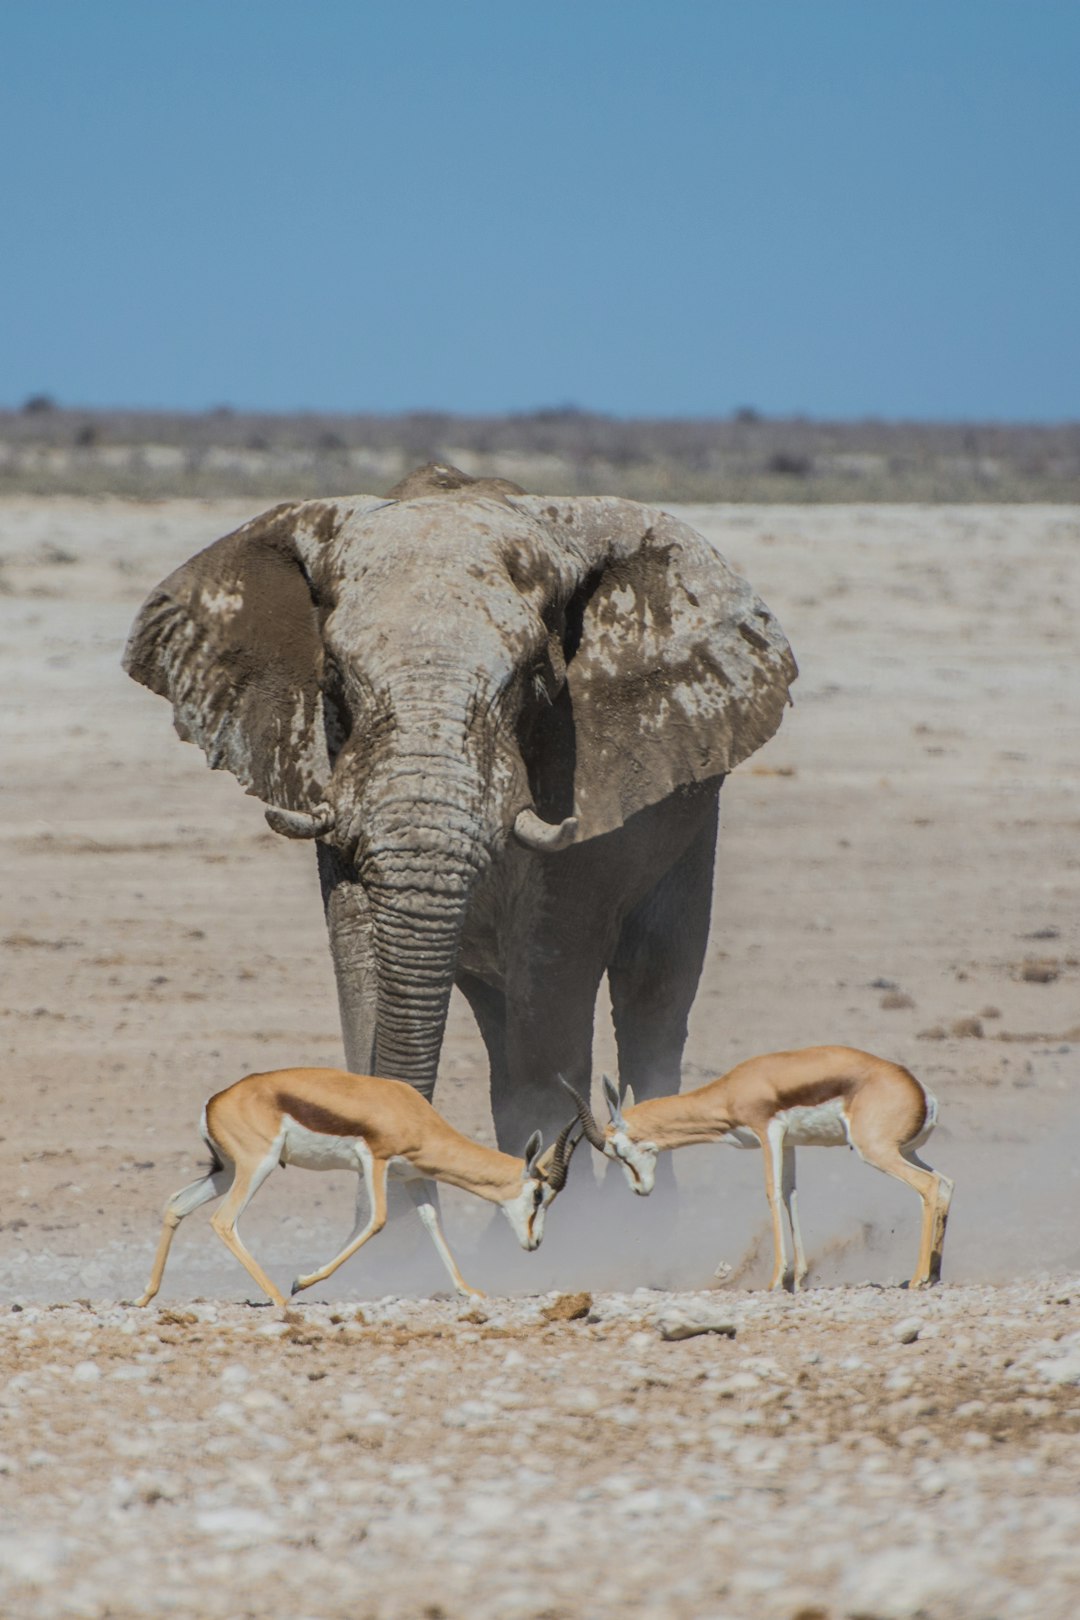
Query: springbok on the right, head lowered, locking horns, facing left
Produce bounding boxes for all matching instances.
[563,1047,952,1288]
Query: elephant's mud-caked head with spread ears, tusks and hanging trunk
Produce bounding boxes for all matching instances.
[125,467,795,1082]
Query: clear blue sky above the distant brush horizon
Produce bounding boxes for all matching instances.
[0,0,1080,420]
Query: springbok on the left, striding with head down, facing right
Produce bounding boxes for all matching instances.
[136,1069,580,1306]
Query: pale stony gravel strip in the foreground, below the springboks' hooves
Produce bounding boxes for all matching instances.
[0,1278,1080,1620]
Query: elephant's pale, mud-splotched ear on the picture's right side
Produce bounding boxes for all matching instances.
[515,497,798,838]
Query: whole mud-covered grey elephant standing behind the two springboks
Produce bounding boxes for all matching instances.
[125,463,797,1152]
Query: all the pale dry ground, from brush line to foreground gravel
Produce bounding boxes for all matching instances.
[0,499,1080,1620]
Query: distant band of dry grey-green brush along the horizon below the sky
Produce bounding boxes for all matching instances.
[0,395,1080,504]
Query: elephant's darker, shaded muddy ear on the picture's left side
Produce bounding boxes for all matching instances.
[123,501,376,810]
